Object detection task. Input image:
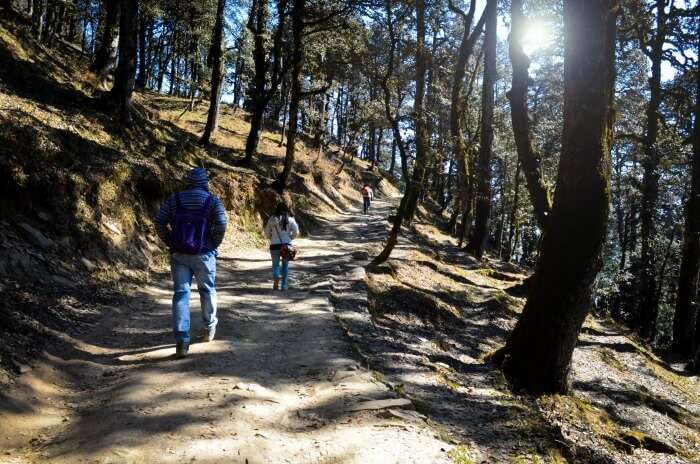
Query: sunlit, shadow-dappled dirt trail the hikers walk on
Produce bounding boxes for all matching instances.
[0,202,450,464]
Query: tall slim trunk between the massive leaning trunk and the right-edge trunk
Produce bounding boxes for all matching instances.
[634,0,666,338]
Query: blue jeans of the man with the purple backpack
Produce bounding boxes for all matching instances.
[170,251,218,343]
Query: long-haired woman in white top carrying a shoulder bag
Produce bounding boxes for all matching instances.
[265,202,299,290]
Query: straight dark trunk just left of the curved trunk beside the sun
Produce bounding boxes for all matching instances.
[467,0,498,259]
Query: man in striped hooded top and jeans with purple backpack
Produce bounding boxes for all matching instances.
[155,168,226,357]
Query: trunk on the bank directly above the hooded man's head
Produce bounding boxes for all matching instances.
[199,0,226,146]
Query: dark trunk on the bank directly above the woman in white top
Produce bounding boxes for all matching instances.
[274,0,306,193]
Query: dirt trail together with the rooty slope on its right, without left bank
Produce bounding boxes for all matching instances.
[0,197,700,464]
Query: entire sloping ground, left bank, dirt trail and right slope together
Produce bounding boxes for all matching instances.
[0,9,700,464]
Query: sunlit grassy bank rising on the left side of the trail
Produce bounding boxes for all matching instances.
[0,15,397,381]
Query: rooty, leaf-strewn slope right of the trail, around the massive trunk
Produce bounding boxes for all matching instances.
[342,214,700,464]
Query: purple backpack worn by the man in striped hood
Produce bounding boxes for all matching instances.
[172,193,211,255]
